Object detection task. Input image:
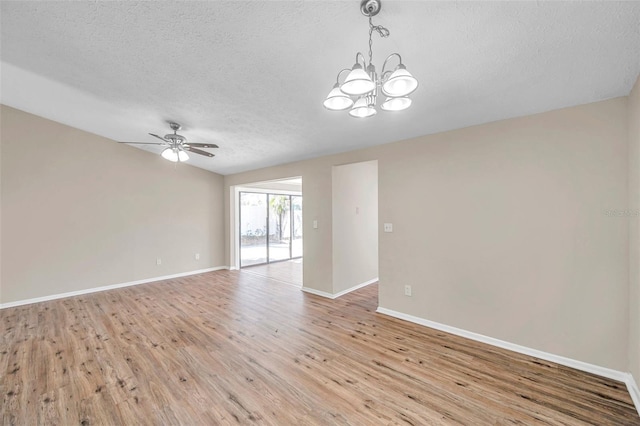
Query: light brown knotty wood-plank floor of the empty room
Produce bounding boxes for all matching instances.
[0,271,640,425]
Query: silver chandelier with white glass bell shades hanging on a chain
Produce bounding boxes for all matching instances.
[323,0,418,118]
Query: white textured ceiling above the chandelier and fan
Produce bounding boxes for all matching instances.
[0,0,640,174]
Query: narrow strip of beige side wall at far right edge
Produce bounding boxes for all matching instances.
[628,76,640,383]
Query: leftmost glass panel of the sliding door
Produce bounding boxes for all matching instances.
[240,192,268,267]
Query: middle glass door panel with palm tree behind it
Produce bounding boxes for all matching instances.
[268,194,291,262]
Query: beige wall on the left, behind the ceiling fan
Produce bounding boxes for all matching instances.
[0,106,224,303]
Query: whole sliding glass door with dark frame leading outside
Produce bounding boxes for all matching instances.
[239,192,302,267]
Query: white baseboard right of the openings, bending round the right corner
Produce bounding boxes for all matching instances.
[376,307,640,414]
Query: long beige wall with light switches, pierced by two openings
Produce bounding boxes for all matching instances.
[225,98,629,371]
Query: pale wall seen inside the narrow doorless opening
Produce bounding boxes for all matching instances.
[331,161,378,294]
